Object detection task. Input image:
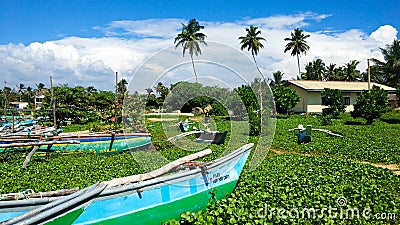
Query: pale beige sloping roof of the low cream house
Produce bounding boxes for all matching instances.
[288,80,396,92]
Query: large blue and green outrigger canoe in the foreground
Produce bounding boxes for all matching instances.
[0,143,253,225]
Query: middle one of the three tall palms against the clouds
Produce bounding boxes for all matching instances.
[239,25,266,80]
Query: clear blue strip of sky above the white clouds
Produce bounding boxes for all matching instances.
[0,0,400,44]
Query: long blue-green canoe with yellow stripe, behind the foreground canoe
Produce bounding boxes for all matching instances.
[0,133,151,155]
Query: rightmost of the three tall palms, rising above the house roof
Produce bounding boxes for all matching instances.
[284,28,310,77]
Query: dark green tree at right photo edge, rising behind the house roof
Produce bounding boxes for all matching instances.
[372,39,400,87]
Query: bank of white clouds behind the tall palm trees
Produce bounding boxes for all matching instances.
[0,13,397,90]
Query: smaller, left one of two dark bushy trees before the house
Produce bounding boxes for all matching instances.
[321,88,346,118]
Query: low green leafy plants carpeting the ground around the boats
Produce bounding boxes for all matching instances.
[0,115,400,224]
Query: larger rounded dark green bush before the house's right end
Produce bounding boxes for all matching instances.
[351,85,389,124]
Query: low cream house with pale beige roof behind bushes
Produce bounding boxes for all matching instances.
[285,80,396,113]
